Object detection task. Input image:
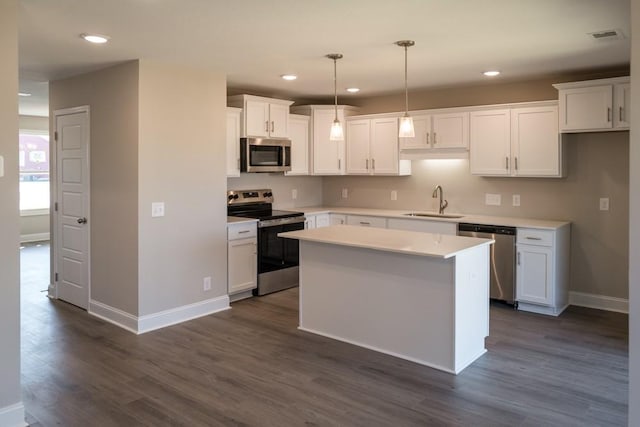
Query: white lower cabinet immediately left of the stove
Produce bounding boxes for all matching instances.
[227,222,258,301]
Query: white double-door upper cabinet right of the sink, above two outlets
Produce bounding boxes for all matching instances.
[469,101,562,177]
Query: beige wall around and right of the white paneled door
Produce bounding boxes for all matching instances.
[49,61,138,315]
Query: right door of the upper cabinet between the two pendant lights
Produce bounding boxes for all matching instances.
[369,117,399,175]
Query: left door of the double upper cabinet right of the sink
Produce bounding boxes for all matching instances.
[469,109,511,176]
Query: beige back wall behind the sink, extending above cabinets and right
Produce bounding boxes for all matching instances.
[323,77,629,298]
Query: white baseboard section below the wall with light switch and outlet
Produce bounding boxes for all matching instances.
[138,295,231,334]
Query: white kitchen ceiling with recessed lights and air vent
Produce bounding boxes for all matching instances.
[19,0,630,114]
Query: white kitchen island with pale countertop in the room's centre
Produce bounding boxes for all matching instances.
[279,225,493,374]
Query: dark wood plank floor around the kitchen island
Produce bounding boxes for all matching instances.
[22,242,628,426]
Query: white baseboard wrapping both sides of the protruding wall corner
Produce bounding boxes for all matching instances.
[89,295,231,336]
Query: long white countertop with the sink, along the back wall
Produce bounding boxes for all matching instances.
[295,206,570,230]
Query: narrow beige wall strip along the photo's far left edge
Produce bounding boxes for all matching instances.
[0,0,23,425]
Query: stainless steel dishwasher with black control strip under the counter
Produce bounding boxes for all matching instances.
[458,223,517,307]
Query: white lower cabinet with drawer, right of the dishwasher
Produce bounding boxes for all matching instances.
[516,225,570,316]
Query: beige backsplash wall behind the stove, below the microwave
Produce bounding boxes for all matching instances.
[227,173,322,209]
